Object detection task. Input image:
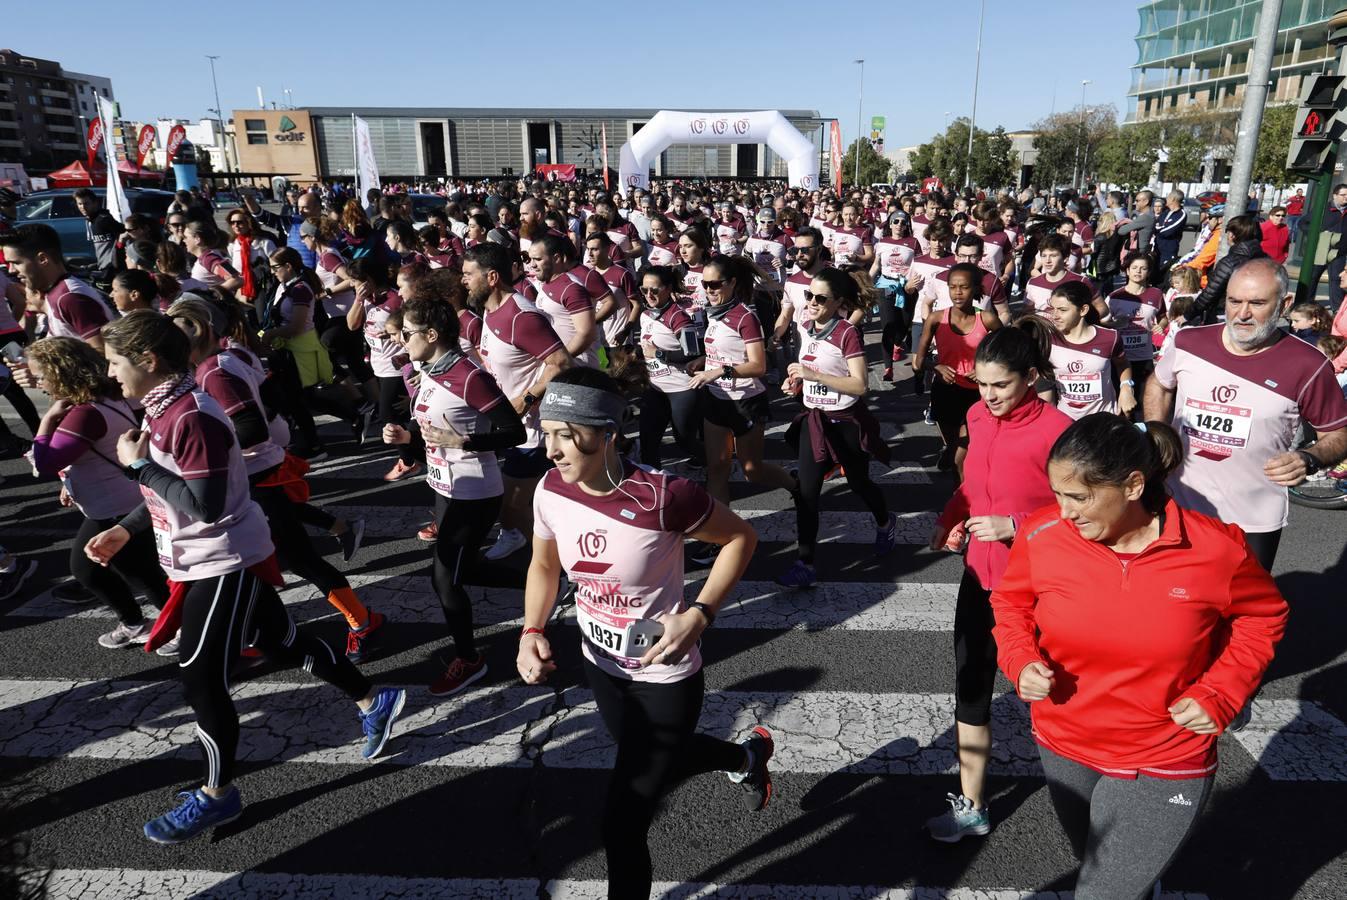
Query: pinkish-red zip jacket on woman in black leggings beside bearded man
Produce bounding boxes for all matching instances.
[940,391,1071,590]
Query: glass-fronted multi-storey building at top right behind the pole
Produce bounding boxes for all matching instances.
[1126,0,1343,123]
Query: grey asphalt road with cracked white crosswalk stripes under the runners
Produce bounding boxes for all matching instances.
[0,323,1347,900]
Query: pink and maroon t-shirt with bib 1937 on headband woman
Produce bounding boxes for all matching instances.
[533,461,715,683]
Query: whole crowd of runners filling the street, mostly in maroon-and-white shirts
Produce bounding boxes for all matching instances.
[0,170,1347,897]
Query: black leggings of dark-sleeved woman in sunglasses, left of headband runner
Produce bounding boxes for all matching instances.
[430,493,501,660]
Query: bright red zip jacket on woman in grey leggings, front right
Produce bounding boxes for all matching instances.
[991,500,1286,777]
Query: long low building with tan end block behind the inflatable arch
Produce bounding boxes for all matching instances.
[233,106,826,182]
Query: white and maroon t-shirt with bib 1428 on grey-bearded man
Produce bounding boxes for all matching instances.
[1154,325,1347,534]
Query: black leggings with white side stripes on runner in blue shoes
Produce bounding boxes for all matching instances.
[178,570,369,788]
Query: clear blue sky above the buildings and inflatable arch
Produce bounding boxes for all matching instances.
[3,0,1137,147]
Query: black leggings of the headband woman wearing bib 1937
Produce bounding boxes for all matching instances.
[585,659,746,900]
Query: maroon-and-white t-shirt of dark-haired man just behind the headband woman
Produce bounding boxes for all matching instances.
[478,294,564,449]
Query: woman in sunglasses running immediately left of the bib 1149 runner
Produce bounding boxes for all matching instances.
[683,253,797,565]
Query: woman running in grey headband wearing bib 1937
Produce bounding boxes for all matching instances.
[516,368,773,900]
